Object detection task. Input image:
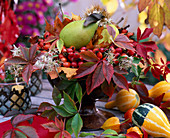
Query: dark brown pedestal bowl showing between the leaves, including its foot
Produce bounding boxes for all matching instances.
[47,76,114,130]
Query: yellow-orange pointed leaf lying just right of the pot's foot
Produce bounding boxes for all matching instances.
[101,117,120,133]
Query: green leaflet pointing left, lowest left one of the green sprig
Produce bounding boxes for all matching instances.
[52,106,74,117]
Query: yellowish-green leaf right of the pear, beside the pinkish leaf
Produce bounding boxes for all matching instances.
[98,29,112,44]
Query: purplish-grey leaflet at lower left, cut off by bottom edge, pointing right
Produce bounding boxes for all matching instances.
[16,126,39,138]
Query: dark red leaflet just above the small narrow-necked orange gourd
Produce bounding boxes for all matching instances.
[113,73,129,90]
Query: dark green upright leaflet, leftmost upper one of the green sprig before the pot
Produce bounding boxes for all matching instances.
[52,86,62,105]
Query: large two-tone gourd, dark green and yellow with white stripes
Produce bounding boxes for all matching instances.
[132,103,170,138]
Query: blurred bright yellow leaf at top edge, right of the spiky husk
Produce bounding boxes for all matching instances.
[101,0,119,15]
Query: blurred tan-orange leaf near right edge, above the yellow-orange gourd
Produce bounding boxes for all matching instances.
[155,49,167,65]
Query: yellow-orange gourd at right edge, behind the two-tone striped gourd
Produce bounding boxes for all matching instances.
[148,81,170,101]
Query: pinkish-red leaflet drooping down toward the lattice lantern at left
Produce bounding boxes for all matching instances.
[22,64,33,84]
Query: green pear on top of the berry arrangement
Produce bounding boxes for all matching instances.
[60,20,98,49]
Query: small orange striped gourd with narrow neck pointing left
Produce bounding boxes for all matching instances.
[105,89,140,112]
